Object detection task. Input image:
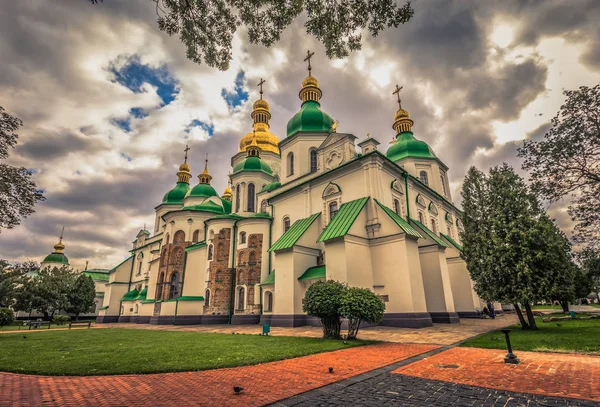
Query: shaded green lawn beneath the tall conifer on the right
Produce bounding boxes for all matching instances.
[461,318,600,355]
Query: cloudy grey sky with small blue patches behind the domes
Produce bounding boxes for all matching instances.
[0,0,600,269]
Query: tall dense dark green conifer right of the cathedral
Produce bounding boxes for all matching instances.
[461,164,574,328]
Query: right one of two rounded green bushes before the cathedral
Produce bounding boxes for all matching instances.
[340,287,385,339]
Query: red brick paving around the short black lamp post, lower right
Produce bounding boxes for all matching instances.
[392,348,600,401]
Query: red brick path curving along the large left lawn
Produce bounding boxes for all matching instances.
[0,343,438,407]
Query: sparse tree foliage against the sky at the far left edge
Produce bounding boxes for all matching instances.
[0,106,45,231]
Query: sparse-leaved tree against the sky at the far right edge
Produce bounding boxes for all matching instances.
[518,84,600,245]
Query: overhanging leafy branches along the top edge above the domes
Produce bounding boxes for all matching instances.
[90,0,414,70]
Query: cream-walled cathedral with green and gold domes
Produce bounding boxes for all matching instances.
[88,55,481,328]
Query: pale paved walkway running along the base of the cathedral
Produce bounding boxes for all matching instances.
[97,314,518,345]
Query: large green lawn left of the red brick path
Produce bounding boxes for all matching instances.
[0,328,373,375]
